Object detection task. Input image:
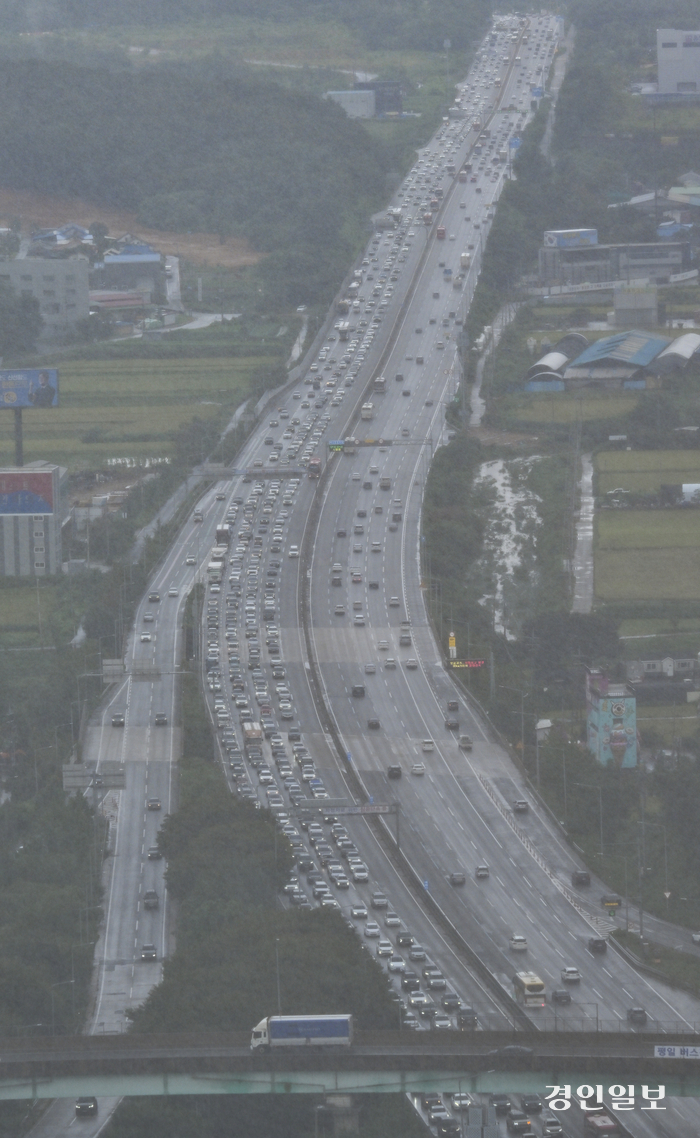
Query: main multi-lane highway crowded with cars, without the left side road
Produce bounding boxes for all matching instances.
[88,8,697,1136]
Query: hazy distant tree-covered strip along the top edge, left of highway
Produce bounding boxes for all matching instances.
[0,0,492,51]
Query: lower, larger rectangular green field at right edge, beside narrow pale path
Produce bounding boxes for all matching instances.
[595,510,700,601]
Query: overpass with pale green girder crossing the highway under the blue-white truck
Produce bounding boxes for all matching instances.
[0,1031,700,1099]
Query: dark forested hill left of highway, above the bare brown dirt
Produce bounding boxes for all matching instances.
[0,60,388,303]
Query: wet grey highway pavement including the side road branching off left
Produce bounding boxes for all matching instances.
[34,8,700,1138]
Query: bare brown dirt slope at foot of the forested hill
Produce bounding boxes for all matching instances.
[0,188,260,269]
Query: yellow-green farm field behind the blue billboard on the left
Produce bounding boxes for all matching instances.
[0,356,267,471]
